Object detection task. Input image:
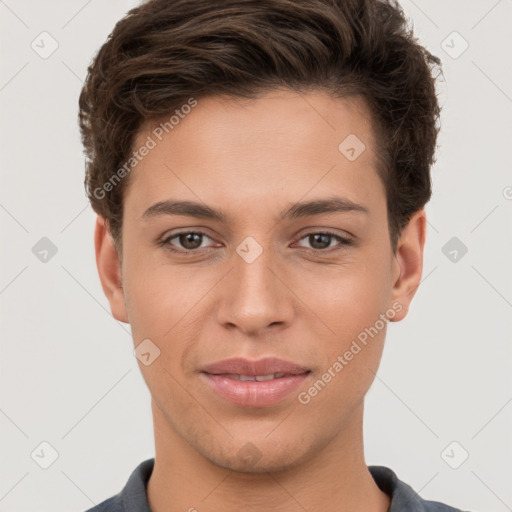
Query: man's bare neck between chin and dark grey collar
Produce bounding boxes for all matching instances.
[147,403,390,512]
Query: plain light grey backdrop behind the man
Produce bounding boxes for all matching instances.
[0,0,512,512]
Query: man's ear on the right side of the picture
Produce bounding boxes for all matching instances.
[390,209,427,322]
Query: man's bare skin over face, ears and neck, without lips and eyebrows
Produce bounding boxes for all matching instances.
[95,89,426,512]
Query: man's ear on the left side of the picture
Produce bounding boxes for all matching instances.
[94,215,128,323]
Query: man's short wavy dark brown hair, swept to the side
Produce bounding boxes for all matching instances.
[79,0,440,249]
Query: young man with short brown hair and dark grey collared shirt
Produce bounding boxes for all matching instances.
[80,0,468,512]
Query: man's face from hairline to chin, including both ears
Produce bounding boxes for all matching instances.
[97,90,424,472]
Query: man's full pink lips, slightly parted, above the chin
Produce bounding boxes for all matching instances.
[200,357,310,407]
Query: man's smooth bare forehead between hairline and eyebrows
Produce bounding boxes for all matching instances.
[125,89,384,220]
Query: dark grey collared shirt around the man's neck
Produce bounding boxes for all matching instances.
[86,458,468,512]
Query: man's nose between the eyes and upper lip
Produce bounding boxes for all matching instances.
[218,240,295,336]
